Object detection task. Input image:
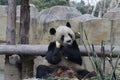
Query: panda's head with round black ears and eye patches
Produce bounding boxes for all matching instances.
[50,22,75,45]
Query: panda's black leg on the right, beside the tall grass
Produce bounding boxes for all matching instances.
[76,69,96,79]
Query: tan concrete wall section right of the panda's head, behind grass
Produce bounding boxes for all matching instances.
[80,19,111,45]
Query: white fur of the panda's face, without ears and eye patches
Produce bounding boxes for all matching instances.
[55,26,75,45]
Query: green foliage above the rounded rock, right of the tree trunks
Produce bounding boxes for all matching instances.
[30,0,67,11]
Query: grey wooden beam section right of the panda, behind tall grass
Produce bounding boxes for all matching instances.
[79,45,120,57]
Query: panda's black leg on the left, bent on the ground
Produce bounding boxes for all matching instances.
[36,65,53,78]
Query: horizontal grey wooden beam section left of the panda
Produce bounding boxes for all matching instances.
[0,44,47,55]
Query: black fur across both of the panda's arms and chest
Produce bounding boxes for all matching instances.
[46,41,82,65]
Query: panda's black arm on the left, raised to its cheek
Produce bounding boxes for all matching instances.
[46,42,61,65]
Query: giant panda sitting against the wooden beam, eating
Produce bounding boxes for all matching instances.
[36,22,94,79]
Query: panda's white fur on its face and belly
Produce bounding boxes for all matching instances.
[51,25,81,70]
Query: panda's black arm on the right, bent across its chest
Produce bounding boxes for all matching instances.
[62,41,82,65]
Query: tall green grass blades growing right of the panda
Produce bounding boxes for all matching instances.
[82,28,120,80]
